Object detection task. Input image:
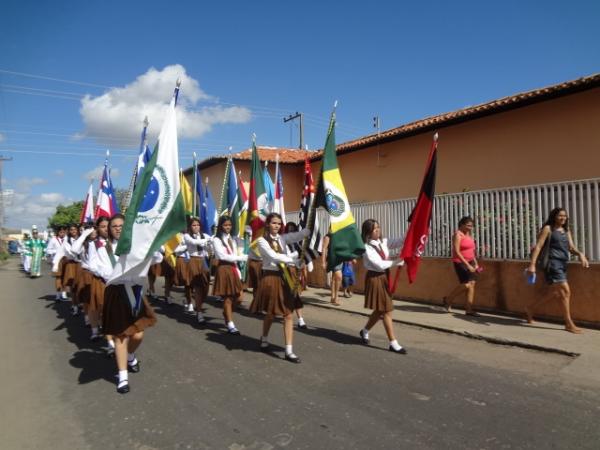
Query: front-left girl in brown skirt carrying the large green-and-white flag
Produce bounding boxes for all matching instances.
[96,214,156,394]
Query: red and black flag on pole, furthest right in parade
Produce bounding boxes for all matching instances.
[400,133,438,283]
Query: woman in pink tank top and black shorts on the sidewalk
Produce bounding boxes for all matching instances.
[442,216,480,316]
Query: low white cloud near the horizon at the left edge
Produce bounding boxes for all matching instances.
[5,192,72,229]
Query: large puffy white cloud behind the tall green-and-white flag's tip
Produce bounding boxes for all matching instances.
[79,64,251,146]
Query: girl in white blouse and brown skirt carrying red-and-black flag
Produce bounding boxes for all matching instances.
[359,219,406,354]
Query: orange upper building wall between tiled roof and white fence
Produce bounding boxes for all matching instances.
[313,88,600,203]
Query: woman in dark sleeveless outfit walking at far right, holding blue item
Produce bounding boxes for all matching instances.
[525,208,590,333]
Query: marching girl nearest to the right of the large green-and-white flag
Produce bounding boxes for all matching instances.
[183,217,211,323]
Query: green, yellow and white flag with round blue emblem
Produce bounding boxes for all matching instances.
[316,110,365,271]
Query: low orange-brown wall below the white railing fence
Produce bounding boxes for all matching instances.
[309,258,600,327]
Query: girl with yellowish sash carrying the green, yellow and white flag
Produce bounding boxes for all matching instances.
[250,213,310,363]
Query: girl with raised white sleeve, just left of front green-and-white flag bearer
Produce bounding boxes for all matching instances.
[71,227,100,341]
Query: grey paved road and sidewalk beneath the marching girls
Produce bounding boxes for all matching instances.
[0,260,600,450]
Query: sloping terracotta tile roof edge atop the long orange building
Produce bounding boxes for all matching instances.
[328,73,600,159]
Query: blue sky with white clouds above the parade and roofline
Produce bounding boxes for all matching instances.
[0,0,600,227]
